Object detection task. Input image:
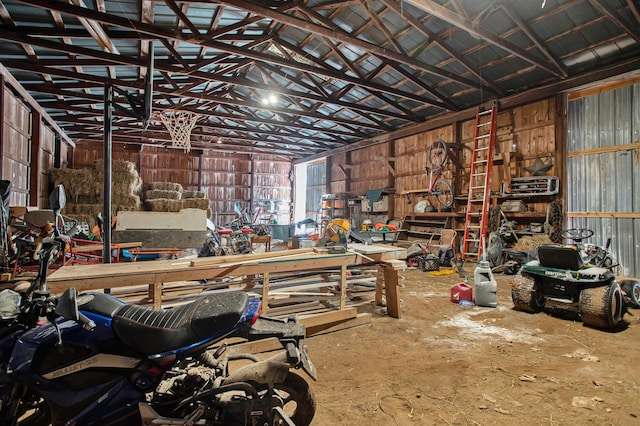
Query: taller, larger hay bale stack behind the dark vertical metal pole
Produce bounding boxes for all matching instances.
[50,160,142,227]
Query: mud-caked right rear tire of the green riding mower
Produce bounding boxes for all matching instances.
[580,281,624,328]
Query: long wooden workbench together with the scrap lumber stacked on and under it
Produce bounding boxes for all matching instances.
[48,246,406,332]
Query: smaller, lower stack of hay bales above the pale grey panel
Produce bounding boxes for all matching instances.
[144,182,211,217]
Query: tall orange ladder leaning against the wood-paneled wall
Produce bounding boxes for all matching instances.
[462,103,498,264]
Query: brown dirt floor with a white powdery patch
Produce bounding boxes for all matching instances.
[306,264,640,426]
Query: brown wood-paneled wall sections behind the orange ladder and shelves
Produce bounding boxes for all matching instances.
[331,95,566,218]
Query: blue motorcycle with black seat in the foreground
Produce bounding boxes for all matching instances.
[0,186,316,426]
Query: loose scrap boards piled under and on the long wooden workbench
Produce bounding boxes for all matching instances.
[112,246,406,333]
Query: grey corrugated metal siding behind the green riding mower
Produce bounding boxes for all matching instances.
[567,84,640,277]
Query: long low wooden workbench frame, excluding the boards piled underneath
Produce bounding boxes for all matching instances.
[47,245,406,318]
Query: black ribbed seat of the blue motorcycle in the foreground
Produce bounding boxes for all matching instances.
[112,292,249,355]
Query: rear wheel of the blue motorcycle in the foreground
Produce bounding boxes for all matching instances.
[257,372,316,426]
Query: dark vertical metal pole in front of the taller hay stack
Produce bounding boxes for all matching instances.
[102,83,113,263]
